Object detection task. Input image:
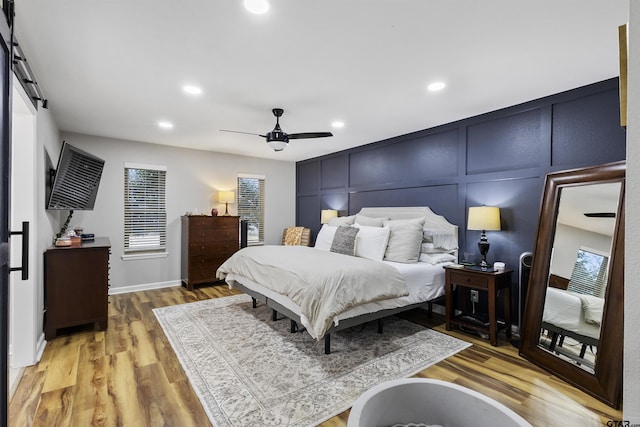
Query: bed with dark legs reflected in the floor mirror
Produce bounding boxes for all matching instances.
[542,287,604,367]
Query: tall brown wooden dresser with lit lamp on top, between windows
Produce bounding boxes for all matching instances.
[181,215,240,291]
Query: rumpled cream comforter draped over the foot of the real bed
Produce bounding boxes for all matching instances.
[217,246,409,339]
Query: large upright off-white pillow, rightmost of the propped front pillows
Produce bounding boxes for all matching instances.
[384,218,424,263]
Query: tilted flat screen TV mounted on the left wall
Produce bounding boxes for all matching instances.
[47,142,104,210]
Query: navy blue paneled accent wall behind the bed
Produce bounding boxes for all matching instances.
[296,78,626,324]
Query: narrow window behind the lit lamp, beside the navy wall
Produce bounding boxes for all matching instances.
[238,174,264,245]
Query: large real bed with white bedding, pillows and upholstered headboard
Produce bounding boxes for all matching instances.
[217,207,458,354]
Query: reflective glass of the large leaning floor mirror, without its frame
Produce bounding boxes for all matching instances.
[538,182,621,373]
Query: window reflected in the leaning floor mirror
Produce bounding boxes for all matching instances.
[567,248,609,298]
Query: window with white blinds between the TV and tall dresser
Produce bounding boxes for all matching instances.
[124,163,167,252]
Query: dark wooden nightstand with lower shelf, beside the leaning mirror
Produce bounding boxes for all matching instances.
[444,266,513,346]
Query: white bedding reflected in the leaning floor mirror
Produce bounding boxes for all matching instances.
[542,287,604,339]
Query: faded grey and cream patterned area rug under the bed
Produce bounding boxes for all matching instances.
[153,295,470,427]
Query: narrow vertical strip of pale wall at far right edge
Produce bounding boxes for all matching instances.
[623,0,640,424]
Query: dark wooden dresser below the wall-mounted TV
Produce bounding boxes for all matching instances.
[44,237,111,340]
